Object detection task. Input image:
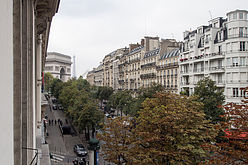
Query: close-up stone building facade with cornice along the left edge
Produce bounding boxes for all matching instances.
[0,0,59,165]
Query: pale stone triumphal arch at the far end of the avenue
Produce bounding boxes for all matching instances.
[44,52,72,82]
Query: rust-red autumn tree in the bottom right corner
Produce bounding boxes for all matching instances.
[212,92,248,165]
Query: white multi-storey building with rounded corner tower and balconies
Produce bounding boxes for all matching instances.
[179,10,248,102]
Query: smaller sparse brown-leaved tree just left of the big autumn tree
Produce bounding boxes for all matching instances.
[97,117,136,165]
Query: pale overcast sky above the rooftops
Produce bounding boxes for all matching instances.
[48,0,248,76]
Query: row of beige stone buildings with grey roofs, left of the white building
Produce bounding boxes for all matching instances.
[87,37,179,93]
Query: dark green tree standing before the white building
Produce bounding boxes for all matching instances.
[194,77,225,123]
